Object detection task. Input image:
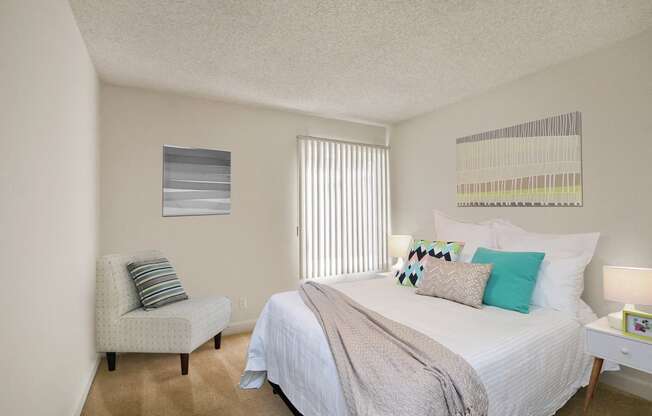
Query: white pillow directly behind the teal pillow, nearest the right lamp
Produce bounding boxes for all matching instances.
[496,230,600,316]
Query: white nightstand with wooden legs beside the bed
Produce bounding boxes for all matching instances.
[584,317,652,412]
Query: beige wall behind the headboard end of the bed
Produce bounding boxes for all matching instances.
[391,31,652,391]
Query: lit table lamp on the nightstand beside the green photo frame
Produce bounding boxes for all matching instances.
[602,266,652,330]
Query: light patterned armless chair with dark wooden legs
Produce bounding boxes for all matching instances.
[95,251,231,374]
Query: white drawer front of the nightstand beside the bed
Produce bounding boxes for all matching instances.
[587,330,652,372]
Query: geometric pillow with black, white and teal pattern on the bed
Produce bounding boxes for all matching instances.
[396,240,464,287]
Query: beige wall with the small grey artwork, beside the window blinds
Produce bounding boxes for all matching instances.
[100,85,385,323]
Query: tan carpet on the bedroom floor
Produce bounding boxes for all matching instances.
[82,334,652,416]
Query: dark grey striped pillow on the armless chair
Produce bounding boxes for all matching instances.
[127,258,188,310]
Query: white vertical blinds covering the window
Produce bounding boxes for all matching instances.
[297,136,389,279]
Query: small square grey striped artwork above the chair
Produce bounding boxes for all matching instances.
[163,145,231,217]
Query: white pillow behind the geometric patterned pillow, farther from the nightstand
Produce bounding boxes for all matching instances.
[433,210,525,263]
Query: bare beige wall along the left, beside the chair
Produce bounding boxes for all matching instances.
[0,0,98,415]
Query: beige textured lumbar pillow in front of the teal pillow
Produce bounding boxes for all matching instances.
[415,257,493,308]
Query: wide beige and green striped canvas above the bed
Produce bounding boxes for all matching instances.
[456,112,582,207]
